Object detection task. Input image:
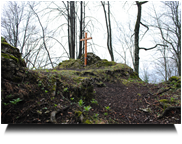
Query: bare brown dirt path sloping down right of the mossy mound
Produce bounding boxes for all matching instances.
[92,83,181,124]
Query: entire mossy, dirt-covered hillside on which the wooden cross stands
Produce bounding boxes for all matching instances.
[1,37,181,124]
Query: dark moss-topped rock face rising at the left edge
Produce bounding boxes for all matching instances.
[1,37,27,116]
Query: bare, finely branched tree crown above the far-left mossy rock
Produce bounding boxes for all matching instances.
[1,1,38,53]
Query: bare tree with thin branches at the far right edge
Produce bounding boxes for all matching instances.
[152,1,181,76]
